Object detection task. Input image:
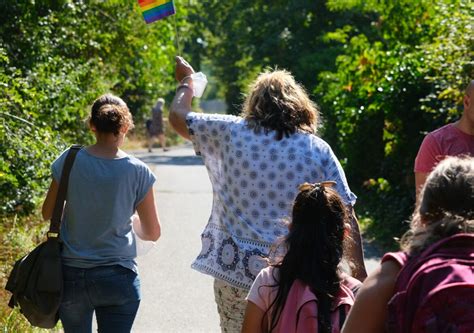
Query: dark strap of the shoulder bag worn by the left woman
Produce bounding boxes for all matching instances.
[47,145,82,239]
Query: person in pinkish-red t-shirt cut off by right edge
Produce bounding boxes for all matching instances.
[415,80,474,198]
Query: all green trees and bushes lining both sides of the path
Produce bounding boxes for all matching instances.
[0,0,474,245]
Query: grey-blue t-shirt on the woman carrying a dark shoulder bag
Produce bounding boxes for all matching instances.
[51,149,156,272]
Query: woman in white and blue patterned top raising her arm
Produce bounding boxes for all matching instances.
[169,57,366,332]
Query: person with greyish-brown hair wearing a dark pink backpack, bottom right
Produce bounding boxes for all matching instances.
[343,157,474,333]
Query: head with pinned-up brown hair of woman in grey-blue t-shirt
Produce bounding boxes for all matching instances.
[89,94,134,136]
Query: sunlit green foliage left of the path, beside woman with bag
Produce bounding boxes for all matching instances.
[0,0,187,215]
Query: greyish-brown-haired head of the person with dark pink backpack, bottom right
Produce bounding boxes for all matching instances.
[402,157,474,253]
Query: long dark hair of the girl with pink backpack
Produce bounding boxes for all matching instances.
[264,183,348,333]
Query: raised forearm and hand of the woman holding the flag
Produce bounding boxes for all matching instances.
[169,57,194,140]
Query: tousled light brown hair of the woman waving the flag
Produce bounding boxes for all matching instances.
[243,70,319,140]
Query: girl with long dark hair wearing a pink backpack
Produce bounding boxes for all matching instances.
[242,182,361,333]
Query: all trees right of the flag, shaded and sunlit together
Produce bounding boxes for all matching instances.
[190,0,473,244]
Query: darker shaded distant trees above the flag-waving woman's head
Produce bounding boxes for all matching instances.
[185,0,370,114]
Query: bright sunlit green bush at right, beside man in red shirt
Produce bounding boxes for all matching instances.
[316,1,474,246]
